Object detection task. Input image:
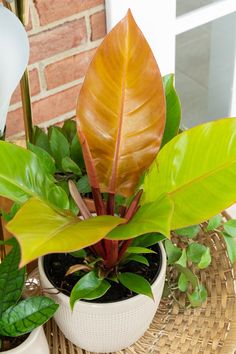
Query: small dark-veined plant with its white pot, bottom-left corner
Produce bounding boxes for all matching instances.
[0,238,58,354]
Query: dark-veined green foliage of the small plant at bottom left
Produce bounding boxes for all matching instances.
[0,238,58,352]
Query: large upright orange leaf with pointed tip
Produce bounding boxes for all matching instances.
[77,11,165,196]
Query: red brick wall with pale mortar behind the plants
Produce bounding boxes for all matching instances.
[7,0,105,138]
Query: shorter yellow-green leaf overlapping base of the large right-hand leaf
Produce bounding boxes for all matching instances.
[106,196,173,240]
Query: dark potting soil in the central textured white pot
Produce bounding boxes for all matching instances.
[44,244,162,303]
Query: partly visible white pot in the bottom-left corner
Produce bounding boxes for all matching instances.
[1,326,49,354]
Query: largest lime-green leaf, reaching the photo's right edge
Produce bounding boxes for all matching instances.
[142,118,236,230]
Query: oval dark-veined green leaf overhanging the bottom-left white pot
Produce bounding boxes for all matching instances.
[0,296,59,337]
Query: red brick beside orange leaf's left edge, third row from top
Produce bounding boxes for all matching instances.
[45,49,95,90]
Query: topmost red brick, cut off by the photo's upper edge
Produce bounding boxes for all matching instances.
[34,0,104,25]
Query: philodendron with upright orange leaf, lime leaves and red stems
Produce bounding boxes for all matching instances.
[0,11,236,307]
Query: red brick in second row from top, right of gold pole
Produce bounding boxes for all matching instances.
[30,18,87,63]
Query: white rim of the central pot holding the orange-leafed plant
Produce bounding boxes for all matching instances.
[38,242,166,310]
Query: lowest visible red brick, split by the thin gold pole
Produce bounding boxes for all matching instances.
[7,85,81,136]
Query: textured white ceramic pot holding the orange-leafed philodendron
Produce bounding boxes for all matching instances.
[39,244,166,353]
